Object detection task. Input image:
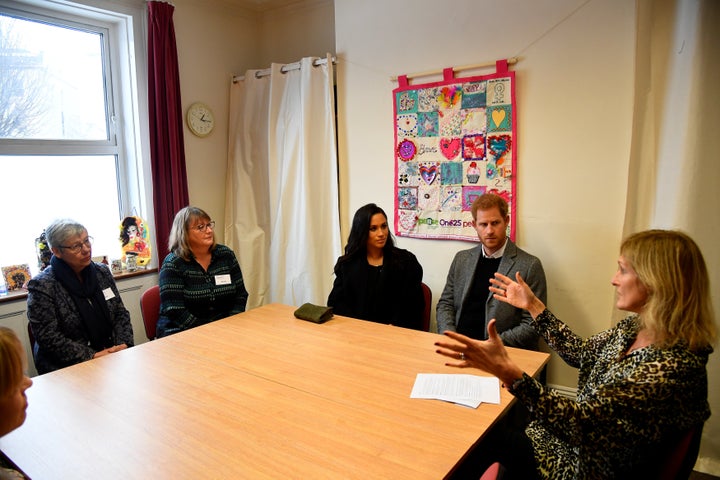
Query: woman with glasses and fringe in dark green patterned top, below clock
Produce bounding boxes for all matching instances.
[157,206,248,337]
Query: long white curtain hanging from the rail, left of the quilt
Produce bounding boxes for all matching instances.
[225,56,342,308]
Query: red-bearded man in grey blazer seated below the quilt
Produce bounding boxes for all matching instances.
[437,194,547,350]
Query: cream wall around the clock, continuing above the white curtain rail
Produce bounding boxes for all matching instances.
[173,0,335,242]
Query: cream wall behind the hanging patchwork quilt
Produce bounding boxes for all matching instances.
[335,0,635,386]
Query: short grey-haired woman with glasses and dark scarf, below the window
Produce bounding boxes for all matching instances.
[27,219,133,374]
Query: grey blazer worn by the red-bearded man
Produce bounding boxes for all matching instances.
[436,240,547,350]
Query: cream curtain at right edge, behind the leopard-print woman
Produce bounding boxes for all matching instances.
[624,0,720,475]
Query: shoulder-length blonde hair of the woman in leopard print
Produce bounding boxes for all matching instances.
[620,230,717,350]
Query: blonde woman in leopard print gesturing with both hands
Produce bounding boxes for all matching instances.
[436,230,717,479]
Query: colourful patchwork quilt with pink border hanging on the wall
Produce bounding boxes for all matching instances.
[393,60,517,241]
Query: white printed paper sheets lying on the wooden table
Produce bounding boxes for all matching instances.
[410,373,500,408]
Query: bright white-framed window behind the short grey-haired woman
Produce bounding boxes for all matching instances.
[0,0,152,275]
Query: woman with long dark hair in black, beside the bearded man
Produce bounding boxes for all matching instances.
[327,203,425,330]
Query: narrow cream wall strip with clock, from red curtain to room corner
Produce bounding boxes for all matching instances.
[173,0,260,242]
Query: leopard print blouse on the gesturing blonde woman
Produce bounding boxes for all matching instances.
[512,310,712,479]
